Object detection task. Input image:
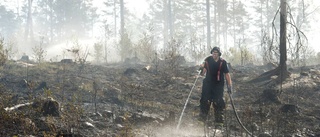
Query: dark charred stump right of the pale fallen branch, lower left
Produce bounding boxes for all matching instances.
[42,98,60,117]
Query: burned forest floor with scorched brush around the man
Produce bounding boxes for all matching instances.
[0,62,320,137]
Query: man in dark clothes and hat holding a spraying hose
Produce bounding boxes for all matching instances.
[200,47,232,127]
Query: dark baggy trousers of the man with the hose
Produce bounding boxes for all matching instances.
[200,81,226,123]
